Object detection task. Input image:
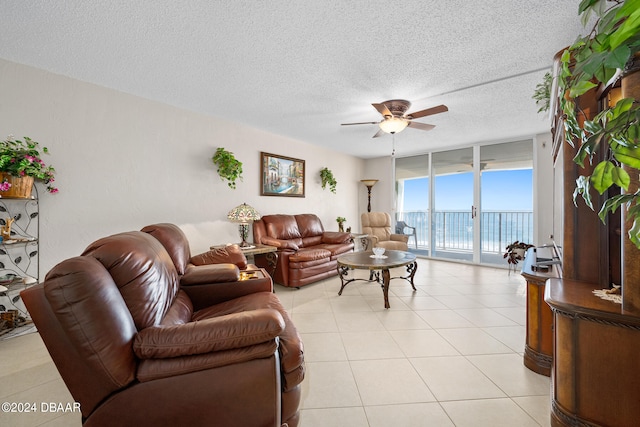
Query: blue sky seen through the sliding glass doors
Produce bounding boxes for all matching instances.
[403,169,533,211]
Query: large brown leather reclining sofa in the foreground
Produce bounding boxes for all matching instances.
[21,224,304,427]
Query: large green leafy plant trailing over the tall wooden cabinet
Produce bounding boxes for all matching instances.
[558,0,640,249]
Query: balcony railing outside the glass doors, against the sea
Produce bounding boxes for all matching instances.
[398,211,533,253]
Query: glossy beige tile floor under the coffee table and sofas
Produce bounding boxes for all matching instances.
[0,259,549,427]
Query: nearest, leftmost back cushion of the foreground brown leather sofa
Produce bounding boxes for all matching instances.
[42,257,137,416]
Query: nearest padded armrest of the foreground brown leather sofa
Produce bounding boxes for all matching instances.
[133,308,285,359]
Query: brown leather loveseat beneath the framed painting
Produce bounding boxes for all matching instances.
[253,214,354,288]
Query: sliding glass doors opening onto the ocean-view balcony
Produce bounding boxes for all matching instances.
[395,140,533,264]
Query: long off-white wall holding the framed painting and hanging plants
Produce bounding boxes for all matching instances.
[0,59,366,279]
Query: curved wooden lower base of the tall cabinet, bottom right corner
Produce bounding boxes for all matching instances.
[545,279,640,427]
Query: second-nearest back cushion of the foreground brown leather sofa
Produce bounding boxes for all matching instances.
[83,231,178,330]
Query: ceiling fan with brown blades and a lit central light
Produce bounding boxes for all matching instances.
[342,99,449,138]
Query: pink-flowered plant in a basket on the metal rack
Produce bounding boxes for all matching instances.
[0,135,58,198]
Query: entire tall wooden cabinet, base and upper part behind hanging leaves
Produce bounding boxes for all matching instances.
[544,48,640,426]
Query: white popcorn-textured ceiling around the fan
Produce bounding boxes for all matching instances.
[0,0,584,158]
